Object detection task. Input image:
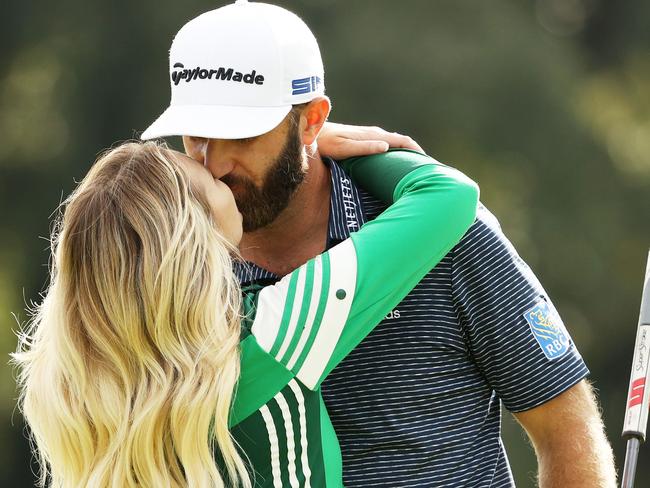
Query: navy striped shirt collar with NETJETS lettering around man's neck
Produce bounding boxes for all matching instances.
[234,157,365,284]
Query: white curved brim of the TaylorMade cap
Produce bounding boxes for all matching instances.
[140,105,291,140]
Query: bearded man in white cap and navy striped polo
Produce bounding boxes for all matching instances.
[143,0,616,488]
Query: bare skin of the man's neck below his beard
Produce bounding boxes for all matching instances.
[239,154,332,276]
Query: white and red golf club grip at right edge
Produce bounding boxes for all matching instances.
[623,252,650,442]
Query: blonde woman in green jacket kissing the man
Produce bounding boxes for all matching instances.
[14,143,478,487]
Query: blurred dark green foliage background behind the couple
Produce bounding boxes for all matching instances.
[0,0,650,487]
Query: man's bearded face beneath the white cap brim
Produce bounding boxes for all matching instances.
[183,113,307,232]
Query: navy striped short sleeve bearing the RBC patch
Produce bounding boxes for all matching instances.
[452,207,589,412]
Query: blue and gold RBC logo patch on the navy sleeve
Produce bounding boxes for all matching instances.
[524,301,571,360]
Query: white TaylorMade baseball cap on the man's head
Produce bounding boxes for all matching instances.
[141,0,325,140]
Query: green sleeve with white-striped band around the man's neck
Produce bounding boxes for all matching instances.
[246,151,478,389]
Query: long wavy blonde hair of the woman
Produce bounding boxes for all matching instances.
[12,142,251,488]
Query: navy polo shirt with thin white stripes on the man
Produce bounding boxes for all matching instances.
[236,161,588,488]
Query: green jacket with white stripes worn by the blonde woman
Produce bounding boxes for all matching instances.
[230,150,478,488]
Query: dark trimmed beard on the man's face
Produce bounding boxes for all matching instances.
[221,119,305,232]
